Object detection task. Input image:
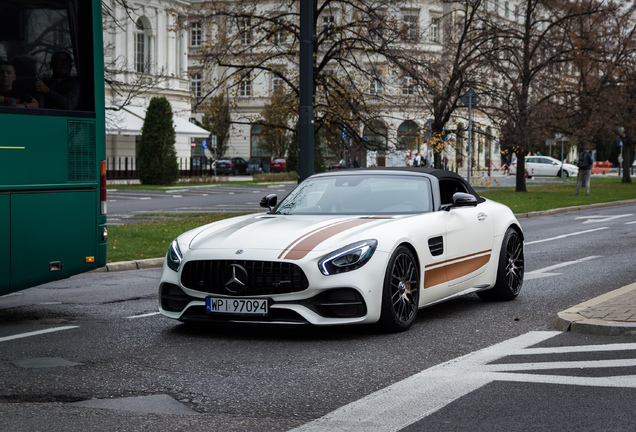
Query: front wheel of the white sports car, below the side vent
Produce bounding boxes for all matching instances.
[378,246,420,332]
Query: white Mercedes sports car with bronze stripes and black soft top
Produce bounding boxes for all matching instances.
[159,168,524,331]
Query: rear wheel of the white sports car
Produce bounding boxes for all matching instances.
[477,228,524,301]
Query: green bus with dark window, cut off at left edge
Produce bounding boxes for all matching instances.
[0,0,108,295]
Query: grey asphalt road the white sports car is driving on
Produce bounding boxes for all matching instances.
[0,205,636,431]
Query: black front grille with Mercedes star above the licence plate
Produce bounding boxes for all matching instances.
[181,260,309,296]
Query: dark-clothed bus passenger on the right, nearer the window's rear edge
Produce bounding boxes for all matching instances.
[35,51,80,110]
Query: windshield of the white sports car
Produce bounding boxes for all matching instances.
[275,174,433,215]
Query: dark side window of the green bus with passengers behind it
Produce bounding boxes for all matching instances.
[0,0,95,114]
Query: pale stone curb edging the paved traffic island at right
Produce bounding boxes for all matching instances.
[554,283,636,336]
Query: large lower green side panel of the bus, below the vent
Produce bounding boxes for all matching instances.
[11,190,98,291]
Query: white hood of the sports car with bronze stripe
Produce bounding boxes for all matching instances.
[189,214,395,259]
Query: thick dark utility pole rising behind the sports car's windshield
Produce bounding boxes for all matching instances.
[298,0,314,183]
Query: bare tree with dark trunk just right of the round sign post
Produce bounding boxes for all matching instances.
[484,0,582,192]
